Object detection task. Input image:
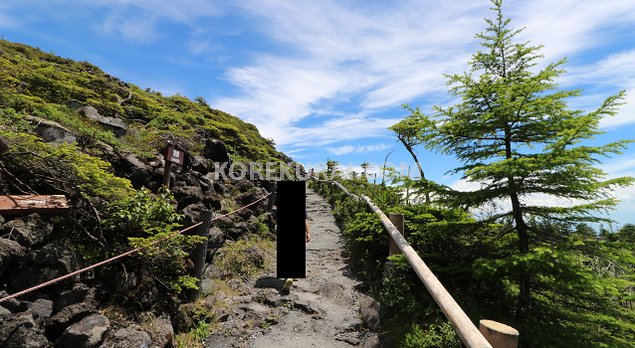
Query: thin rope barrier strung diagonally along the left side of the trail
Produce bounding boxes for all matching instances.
[0,193,271,303]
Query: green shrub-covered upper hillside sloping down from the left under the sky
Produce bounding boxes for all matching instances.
[0,40,288,161]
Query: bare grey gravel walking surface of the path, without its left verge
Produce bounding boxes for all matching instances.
[250,189,367,348]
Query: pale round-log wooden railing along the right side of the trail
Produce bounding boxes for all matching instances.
[318,181,519,348]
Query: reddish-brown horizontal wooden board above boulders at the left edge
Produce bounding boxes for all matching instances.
[0,195,70,215]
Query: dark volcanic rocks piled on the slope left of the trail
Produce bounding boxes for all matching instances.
[0,126,275,348]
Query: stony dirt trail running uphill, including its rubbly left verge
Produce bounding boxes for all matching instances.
[206,189,369,348]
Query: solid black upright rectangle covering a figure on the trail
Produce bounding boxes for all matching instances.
[276,181,306,278]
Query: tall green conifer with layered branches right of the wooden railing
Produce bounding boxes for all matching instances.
[404,0,633,320]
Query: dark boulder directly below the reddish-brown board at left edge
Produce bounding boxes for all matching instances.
[0,213,53,247]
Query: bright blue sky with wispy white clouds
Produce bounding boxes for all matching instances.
[0,0,635,226]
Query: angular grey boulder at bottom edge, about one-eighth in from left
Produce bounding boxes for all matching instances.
[55,314,110,348]
